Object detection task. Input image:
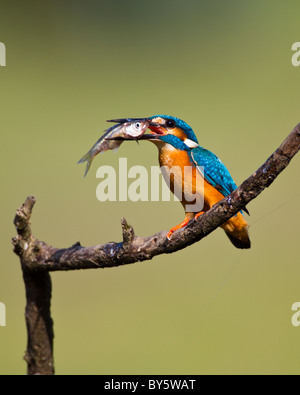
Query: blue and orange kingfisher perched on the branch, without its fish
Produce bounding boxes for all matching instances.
[108,115,251,249]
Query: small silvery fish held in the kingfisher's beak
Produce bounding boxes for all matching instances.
[78,121,150,177]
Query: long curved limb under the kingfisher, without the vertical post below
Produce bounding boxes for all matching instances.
[14,124,300,271]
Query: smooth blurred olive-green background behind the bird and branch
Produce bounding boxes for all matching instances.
[0,0,300,374]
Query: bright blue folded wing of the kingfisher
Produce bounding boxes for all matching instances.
[191,147,237,196]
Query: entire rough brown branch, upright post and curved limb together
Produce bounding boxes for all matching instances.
[12,124,300,375]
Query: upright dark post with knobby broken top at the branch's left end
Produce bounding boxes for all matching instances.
[13,196,54,375]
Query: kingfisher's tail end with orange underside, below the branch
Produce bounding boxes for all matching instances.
[222,213,251,249]
